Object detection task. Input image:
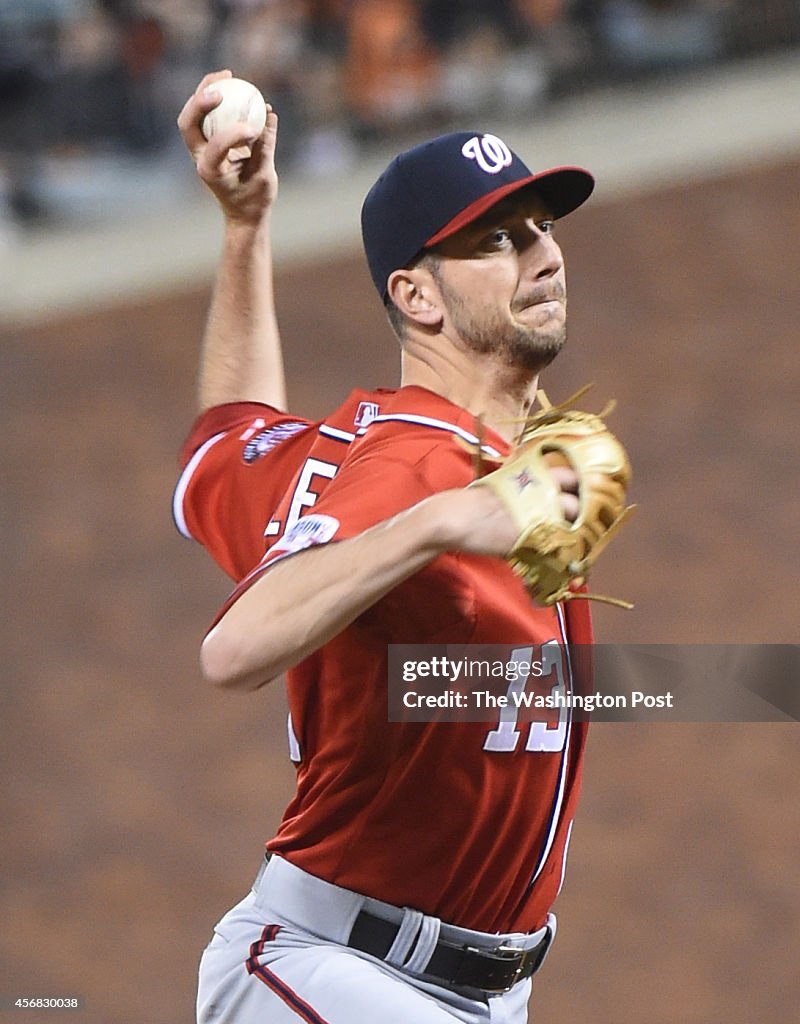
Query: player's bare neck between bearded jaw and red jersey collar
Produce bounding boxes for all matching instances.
[402,350,538,441]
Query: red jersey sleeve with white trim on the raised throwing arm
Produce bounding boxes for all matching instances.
[172,402,314,580]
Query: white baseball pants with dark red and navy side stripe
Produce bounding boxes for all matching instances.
[197,857,555,1024]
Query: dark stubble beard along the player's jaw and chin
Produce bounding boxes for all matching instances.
[439,281,566,375]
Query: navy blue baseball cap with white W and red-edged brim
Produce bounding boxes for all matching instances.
[362,131,594,301]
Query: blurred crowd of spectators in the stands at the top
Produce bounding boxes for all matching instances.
[0,0,800,225]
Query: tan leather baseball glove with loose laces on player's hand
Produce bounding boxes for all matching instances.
[470,392,634,607]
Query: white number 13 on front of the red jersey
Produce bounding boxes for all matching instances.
[483,640,570,754]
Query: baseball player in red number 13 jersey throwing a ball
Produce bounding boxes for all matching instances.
[174,73,606,1024]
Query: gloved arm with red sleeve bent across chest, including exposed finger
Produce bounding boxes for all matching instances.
[201,445,577,690]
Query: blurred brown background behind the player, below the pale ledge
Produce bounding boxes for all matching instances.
[0,155,800,1024]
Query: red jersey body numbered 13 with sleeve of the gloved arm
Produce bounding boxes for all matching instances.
[175,387,591,932]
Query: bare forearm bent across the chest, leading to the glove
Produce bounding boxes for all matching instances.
[201,492,485,690]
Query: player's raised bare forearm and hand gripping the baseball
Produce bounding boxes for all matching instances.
[178,71,286,412]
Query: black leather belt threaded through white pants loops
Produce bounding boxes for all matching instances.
[347,910,552,993]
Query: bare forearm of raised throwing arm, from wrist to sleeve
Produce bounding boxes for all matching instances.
[198,211,286,411]
